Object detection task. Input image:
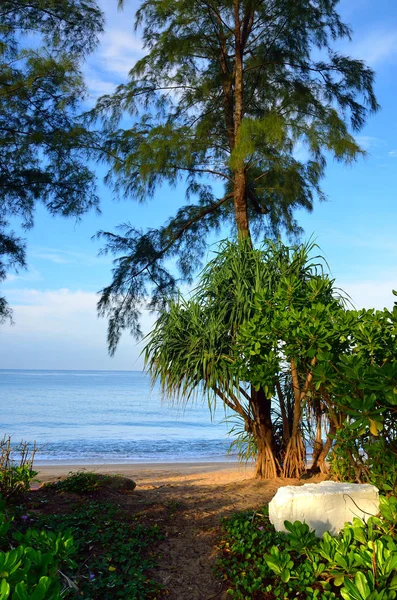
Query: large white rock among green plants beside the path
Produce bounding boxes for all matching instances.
[269,481,379,537]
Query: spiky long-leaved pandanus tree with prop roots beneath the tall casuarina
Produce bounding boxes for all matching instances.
[145,240,343,478]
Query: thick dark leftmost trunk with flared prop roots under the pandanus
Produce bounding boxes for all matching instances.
[251,387,280,479]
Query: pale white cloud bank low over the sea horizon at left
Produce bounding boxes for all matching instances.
[0,288,154,370]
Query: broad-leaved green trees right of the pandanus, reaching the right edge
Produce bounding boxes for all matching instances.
[237,260,397,480]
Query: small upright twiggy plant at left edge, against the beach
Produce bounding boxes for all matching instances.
[0,436,37,498]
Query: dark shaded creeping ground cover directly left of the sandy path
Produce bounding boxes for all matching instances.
[31,501,163,600]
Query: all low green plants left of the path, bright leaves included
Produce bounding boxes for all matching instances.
[0,490,163,600]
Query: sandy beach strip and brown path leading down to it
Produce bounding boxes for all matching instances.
[36,462,310,600]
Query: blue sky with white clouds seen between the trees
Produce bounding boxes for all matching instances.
[0,0,397,370]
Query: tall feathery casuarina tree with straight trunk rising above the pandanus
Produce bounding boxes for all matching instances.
[92,0,378,353]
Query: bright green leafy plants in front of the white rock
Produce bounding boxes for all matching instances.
[219,498,397,600]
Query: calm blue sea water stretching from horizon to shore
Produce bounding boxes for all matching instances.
[0,370,235,464]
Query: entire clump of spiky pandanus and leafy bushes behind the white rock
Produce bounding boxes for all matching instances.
[145,240,397,486]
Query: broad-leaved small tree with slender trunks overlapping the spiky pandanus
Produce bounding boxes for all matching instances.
[236,246,351,478]
